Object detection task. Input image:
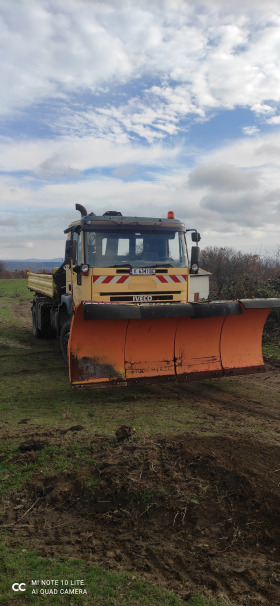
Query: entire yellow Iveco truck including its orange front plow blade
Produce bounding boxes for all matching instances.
[27,204,280,387]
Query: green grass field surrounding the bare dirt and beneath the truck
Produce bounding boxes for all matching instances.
[0,280,279,606]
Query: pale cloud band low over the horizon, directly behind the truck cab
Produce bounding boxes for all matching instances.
[0,140,280,258]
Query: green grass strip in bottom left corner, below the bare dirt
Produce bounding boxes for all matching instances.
[0,543,230,606]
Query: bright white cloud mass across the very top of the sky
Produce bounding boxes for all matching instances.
[0,0,280,126]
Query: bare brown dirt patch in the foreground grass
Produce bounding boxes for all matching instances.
[4,433,280,606]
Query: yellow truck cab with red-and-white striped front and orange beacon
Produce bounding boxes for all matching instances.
[65,211,198,306]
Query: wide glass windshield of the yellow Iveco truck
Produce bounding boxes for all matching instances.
[84,231,187,267]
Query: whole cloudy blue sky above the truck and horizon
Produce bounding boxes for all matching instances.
[0,0,280,260]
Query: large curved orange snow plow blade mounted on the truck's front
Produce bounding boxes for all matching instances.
[68,299,280,387]
